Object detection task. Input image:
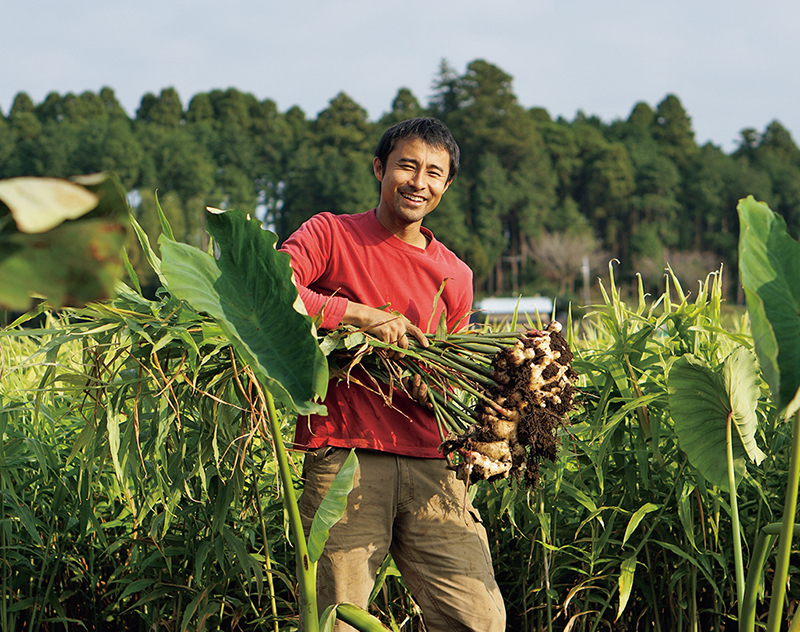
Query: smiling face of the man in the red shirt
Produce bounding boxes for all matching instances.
[372,138,450,227]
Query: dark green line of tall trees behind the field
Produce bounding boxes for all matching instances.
[0,60,800,296]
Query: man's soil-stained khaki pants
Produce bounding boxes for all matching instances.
[299,448,505,632]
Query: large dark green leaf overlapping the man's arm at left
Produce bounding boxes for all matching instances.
[159,211,328,414]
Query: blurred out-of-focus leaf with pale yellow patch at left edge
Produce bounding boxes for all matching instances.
[0,174,128,311]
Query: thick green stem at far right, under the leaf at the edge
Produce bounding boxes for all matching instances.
[767,410,800,632]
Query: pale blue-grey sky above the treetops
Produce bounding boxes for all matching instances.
[0,0,800,151]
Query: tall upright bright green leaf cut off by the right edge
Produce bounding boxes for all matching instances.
[737,196,800,413]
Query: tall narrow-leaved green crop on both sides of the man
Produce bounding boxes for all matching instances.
[0,264,798,632]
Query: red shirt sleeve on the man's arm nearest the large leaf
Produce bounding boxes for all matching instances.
[280,216,348,329]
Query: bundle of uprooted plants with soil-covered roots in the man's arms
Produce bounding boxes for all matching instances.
[322,321,577,487]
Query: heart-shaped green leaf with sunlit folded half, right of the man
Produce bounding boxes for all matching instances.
[667,347,764,491]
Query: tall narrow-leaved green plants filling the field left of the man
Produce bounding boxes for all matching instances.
[0,293,295,630]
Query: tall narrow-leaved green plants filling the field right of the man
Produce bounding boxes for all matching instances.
[472,272,797,632]
